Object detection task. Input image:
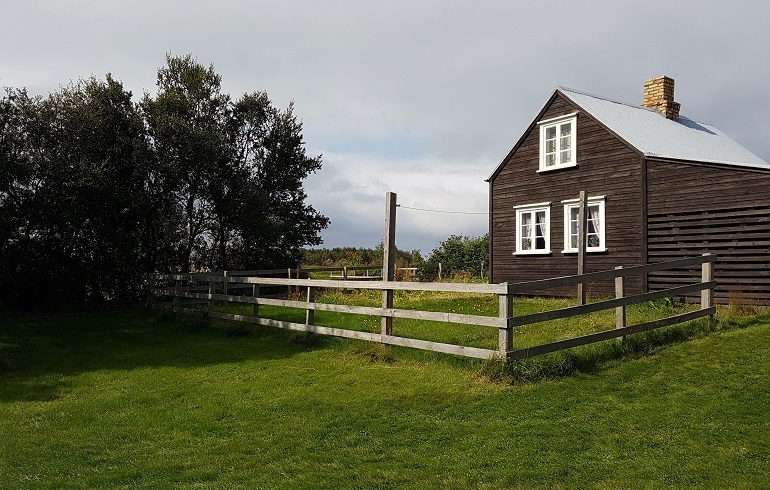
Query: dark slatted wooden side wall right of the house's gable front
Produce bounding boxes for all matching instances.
[647,161,770,304]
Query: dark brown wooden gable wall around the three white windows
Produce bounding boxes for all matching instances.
[490,94,644,295]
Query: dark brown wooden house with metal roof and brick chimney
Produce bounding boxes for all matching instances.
[488,77,770,303]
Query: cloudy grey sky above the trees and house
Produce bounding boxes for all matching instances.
[0,0,770,254]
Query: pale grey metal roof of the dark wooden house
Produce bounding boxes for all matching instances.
[556,87,770,169]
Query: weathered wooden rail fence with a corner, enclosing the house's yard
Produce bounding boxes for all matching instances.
[149,254,716,360]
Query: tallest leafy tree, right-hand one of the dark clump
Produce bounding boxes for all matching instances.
[141,55,329,272]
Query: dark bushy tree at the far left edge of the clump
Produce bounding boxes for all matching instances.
[0,75,145,303]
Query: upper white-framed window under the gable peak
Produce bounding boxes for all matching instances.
[537,113,577,172]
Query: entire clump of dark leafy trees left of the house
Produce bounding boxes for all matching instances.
[0,56,328,306]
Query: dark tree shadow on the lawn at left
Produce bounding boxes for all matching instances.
[0,311,336,402]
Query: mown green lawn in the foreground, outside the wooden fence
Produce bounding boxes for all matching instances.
[0,298,770,489]
